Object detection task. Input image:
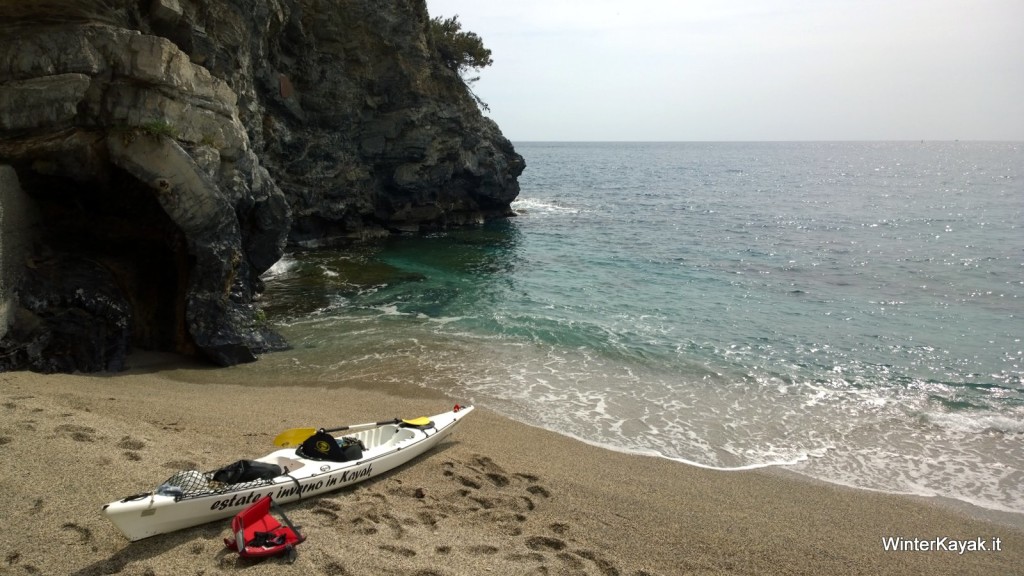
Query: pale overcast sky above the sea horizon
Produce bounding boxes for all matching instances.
[427,0,1024,141]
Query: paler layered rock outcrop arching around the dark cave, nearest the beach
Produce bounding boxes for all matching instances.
[0,3,290,371]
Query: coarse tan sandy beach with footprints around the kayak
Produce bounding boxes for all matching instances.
[0,356,1024,576]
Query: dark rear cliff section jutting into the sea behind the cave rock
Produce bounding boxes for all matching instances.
[167,0,524,243]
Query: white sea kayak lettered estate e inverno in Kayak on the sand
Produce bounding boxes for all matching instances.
[103,406,473,540]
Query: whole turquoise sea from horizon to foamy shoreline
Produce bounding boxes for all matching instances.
[261,142,1024,512]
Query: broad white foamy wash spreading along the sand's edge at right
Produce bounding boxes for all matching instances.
[448,353,1024,512]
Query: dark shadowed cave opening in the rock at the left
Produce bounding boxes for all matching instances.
[23,166,196,355]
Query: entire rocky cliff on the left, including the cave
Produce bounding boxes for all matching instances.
[0,0,524,371]
